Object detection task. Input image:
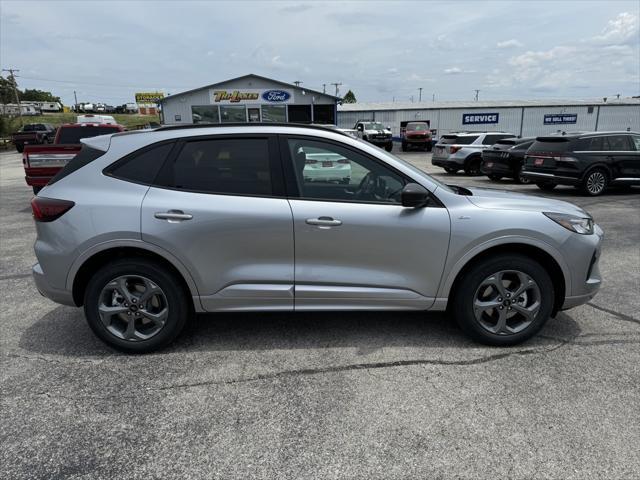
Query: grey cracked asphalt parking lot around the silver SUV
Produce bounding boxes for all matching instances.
[0,147,640,479]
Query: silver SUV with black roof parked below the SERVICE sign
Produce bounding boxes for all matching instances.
[431,132,515,175]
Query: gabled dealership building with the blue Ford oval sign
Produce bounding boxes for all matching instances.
[159,74,340,125]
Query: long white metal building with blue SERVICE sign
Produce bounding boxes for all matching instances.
[338,98,640,138]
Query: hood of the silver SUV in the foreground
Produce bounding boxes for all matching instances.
[467,188,590,216]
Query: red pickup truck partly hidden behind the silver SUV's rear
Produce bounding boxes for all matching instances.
[22,123,124,194]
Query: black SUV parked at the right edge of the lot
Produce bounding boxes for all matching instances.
[522,132,640,196]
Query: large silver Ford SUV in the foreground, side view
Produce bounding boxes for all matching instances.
[32,124,603,352]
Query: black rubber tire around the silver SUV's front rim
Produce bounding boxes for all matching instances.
[451,254,555,346]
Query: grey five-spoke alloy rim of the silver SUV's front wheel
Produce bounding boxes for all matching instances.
[473,270,541,335]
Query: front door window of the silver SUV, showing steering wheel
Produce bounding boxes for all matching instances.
[288,138,406,204]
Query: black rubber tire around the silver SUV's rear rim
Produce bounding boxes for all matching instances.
[84,257,191,353]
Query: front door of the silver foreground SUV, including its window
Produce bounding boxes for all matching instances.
[280,136,450,310]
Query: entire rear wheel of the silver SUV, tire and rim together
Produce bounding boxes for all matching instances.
[84,258,190,353]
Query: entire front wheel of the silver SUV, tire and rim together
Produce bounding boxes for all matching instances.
[452,254,554,346]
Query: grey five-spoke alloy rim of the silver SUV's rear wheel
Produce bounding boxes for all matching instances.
[98,275,169,342]
